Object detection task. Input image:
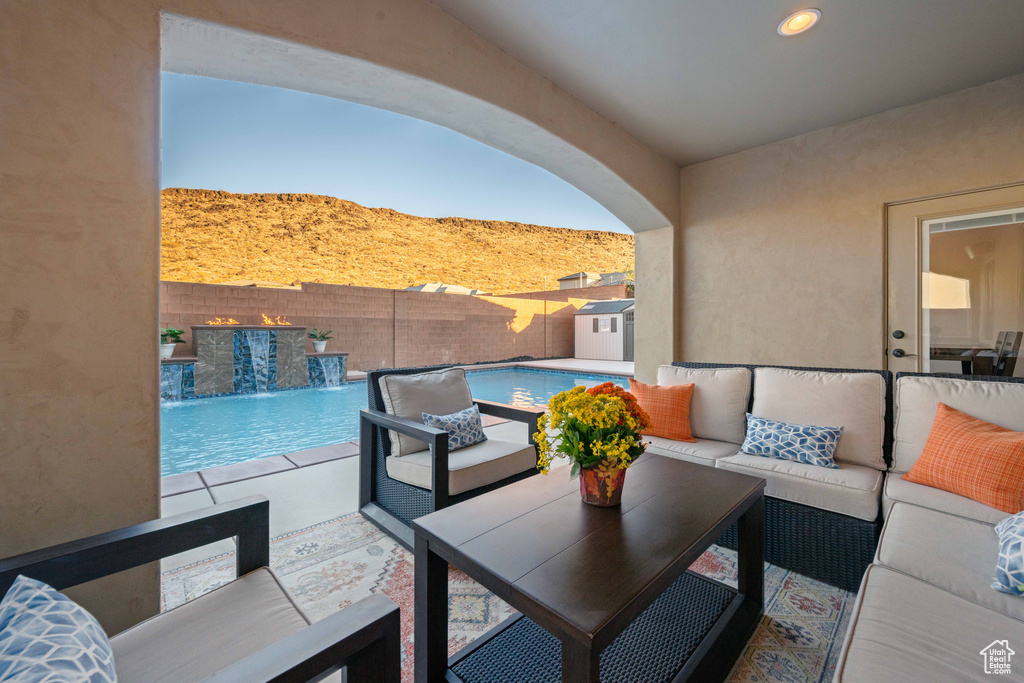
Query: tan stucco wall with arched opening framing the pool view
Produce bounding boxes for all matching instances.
[0,0,679,632]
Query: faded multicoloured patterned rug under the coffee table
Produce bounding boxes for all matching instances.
[161,513,855,683]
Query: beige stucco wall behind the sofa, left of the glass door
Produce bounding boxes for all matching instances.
[679,75,1024,368]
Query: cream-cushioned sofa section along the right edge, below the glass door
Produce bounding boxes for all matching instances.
[836,373,1024,682]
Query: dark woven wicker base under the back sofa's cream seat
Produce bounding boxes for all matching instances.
[718,497,881,592]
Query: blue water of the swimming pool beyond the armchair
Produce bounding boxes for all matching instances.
[160,368,629,476]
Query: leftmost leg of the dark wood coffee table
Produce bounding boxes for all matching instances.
[414,533,447,683]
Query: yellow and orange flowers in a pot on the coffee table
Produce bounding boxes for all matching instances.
[534,382,650,507]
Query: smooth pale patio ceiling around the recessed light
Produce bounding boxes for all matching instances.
[433,0,1024,166]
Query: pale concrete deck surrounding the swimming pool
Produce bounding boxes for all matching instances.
[161,358,633,571]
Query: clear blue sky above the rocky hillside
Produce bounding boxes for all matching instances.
[162,73,629,232]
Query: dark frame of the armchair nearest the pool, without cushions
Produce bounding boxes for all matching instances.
[359,366,544,550]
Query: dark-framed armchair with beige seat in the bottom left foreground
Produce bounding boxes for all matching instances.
[0,496,401,683]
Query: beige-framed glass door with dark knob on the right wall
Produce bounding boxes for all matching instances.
[884,184,1024,377]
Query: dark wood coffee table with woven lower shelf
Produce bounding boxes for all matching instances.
[413,455,765,683]
